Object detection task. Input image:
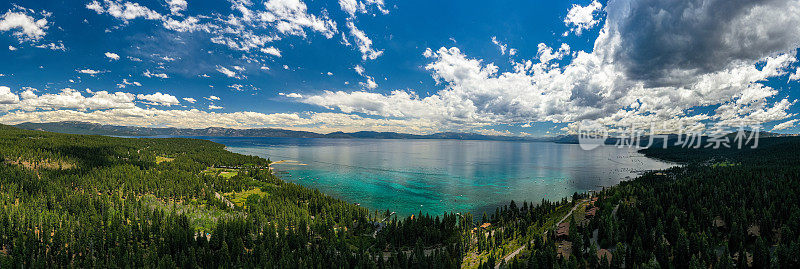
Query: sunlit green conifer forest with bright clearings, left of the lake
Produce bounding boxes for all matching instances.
[0,126,471,268]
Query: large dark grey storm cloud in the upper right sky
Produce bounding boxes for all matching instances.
[607,0,800,86]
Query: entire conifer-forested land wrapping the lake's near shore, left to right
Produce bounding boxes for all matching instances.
[0,126,800,268]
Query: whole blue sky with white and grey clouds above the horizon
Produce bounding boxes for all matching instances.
[0,0,800,136]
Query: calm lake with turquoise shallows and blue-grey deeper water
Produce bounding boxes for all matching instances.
[204,137,672,216]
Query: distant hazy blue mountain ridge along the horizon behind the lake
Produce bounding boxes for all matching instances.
[14,121,552,141]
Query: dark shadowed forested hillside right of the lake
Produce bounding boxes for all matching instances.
[490,137,800,268]
